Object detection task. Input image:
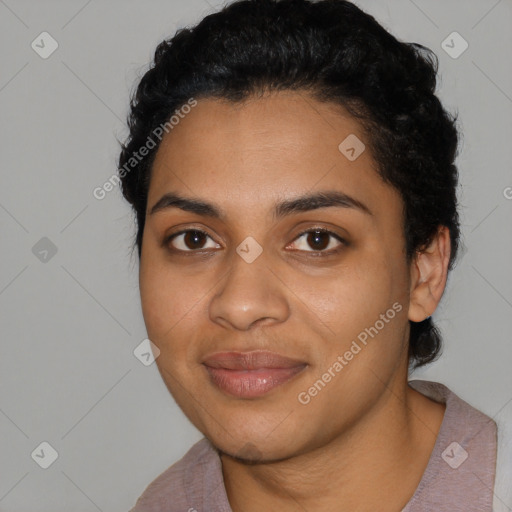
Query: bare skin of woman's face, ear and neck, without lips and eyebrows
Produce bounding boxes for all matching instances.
[139,92,450,512]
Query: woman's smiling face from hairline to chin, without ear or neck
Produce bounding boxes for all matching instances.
[140,92,410,460]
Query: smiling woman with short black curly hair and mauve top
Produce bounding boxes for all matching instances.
[119,0,496,512]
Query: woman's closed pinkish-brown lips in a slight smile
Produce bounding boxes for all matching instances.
[203,351,308,398]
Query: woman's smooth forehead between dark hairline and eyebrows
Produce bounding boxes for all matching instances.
[148,91,396,222]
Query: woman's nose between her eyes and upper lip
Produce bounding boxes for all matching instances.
[209,251,290,331]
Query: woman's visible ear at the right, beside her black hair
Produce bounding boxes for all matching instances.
[409,226,451,322]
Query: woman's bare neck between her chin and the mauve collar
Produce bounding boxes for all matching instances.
[221,379,444,512]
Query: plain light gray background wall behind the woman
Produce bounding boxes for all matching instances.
[0,0,512,512]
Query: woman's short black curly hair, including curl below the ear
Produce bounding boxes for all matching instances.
[118,0,460,368]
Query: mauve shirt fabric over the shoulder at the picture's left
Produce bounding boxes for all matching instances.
[130,438,222,512]
